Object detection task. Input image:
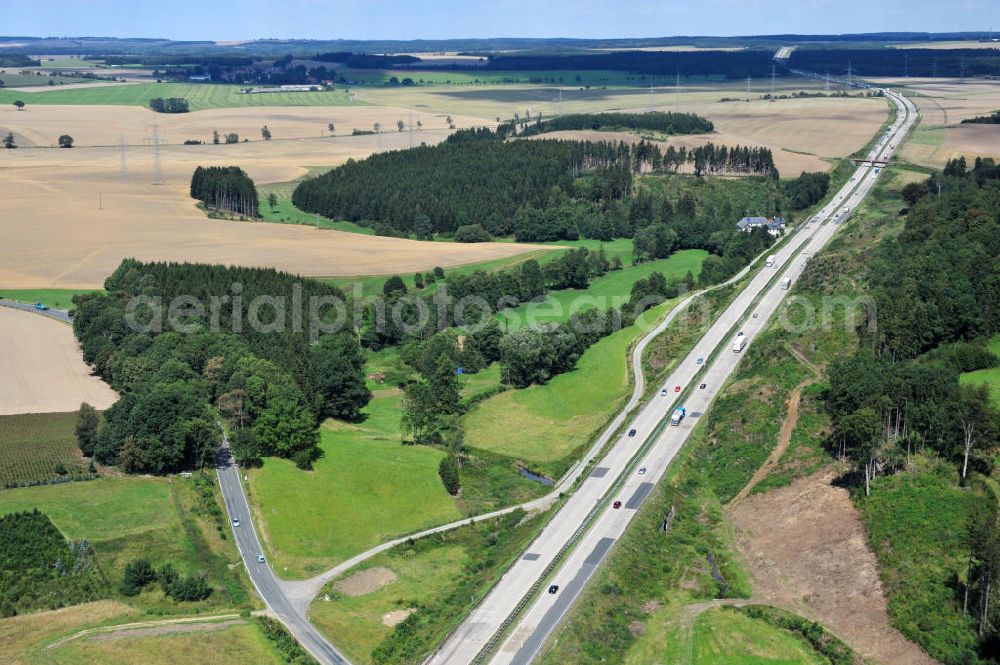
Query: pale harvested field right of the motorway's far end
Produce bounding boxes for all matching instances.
[874,78,1000,168]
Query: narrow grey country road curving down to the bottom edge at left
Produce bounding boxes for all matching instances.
[215,433,350,665]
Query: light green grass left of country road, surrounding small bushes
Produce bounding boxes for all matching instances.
[0,473,253,614]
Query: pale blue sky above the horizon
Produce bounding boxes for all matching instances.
[7,0,1000,40]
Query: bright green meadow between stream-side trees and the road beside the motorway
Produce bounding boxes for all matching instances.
[465,302,674,470]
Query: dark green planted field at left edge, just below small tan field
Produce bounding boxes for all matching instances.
[0,413,87,487]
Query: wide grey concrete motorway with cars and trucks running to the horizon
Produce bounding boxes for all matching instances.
[428,83,916,665]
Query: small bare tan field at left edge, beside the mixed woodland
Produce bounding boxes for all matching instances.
[0,307,118,416]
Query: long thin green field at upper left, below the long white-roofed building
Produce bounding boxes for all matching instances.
[0,83,356,111]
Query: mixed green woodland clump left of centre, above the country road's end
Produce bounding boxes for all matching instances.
[73,259,370,473]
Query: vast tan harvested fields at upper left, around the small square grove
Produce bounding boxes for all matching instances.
[0,106,552,289]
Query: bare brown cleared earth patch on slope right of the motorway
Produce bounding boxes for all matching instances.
[726,468,936,665]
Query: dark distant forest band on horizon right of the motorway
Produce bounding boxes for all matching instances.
[790,48,1000,77]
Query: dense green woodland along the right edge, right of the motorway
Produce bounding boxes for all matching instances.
[825,160,1000,491]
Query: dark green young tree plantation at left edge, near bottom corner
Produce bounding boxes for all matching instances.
[0,510,107,617]
